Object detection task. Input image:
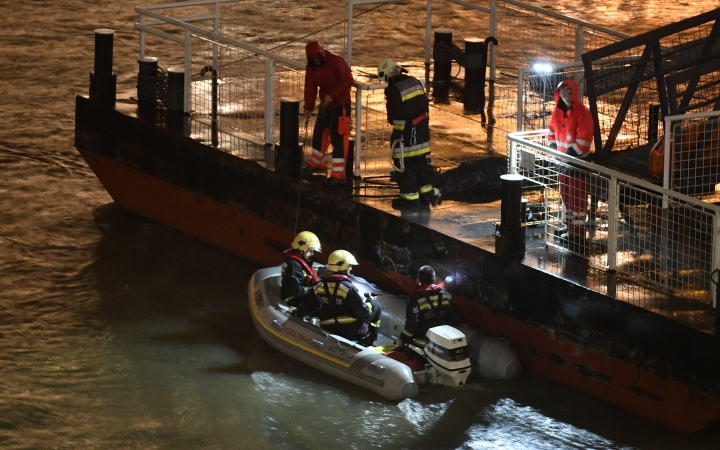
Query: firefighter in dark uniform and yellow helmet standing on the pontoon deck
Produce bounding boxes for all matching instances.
[378,58,441,209]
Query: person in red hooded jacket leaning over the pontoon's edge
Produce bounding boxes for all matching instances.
[303,41,354,187]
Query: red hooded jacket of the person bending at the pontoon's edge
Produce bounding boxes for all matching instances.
[303,41,354,111]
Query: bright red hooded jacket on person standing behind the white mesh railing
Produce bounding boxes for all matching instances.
[548,80,594,158]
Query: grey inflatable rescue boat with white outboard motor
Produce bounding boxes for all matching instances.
[248,266,522,400]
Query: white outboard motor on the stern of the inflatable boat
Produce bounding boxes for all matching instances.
[415,325,472,386]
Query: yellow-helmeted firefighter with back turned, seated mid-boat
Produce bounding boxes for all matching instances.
[293,250,382,346]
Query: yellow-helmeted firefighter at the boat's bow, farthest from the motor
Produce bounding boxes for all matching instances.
[280,231,320,306]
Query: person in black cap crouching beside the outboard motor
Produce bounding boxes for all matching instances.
[398,266,462,348]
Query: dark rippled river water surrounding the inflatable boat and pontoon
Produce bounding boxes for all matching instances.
[0,0,720,449]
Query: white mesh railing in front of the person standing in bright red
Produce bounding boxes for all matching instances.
[508,130,720,307]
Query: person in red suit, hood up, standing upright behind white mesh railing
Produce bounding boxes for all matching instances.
[548,80,594,245]
